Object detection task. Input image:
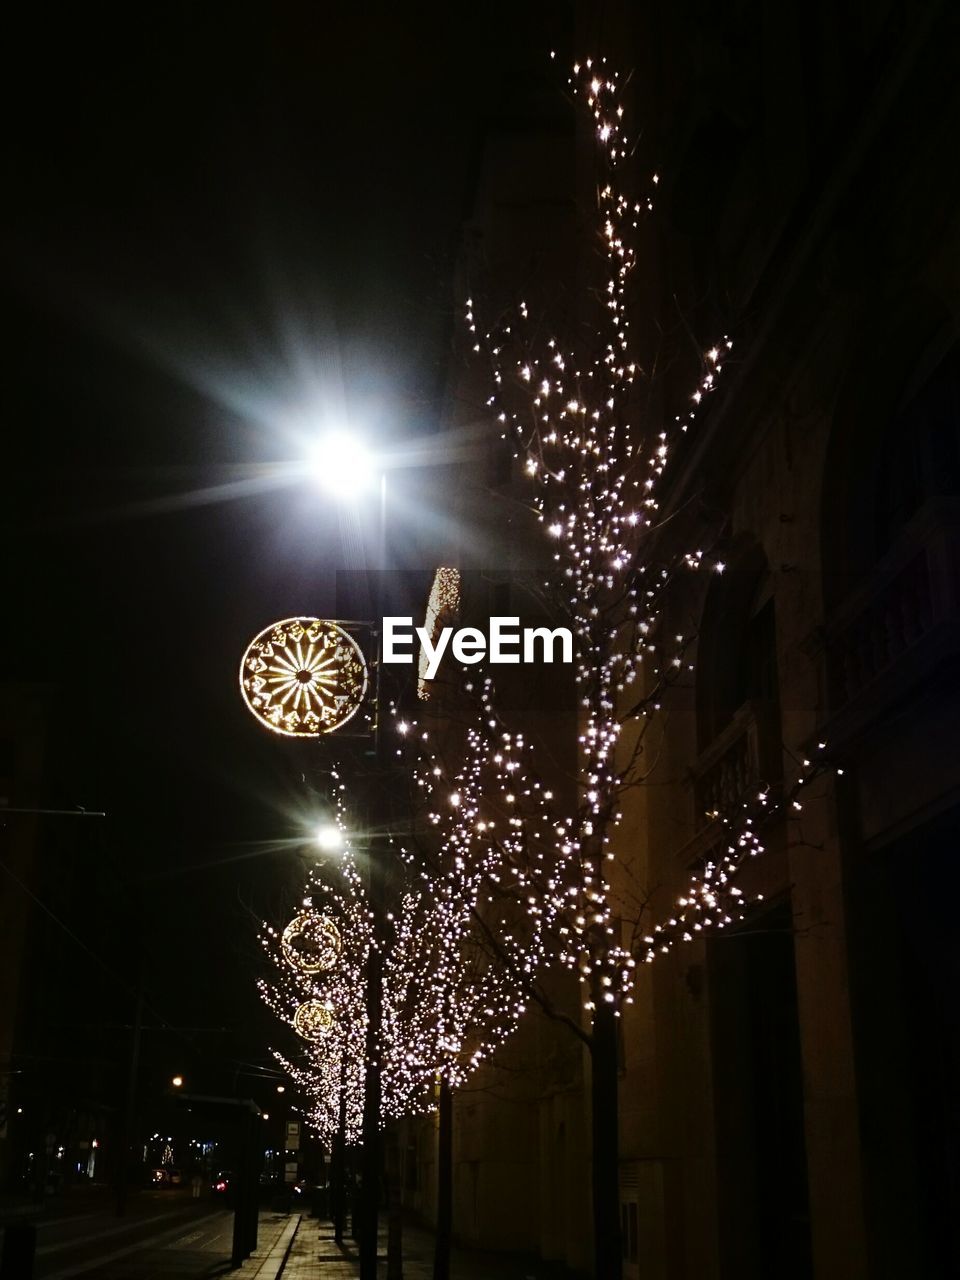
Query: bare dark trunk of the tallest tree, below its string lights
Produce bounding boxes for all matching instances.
[590,1004,623,1280]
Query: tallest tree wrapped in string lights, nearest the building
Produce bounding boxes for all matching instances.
[412,61,834,1280]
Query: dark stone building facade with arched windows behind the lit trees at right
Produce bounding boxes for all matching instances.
[408,4,960,1280]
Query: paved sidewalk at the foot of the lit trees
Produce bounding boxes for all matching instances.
[273,1217,575,1280]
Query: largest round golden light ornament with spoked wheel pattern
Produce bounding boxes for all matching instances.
[239,618,369,737]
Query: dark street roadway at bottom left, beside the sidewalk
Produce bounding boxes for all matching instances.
[0,1190,285,1280]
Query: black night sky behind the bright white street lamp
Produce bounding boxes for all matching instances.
[1,3,568,1095]
